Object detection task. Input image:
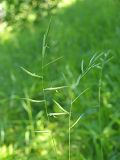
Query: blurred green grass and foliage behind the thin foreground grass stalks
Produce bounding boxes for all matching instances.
[0,0,120,160]
